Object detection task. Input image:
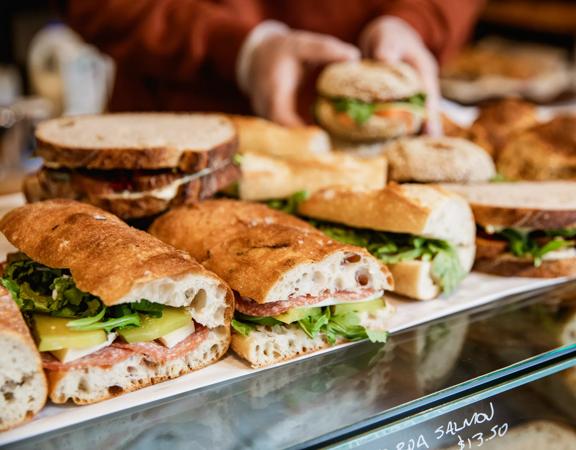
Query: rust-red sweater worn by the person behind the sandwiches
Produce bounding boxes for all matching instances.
[64,0,484,113]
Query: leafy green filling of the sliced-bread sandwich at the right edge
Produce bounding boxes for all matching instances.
[478,226,576,267]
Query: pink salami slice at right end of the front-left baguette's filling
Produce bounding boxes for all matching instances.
[112,324,208,363]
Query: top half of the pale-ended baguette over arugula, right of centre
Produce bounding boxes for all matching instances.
[298,183,475,246]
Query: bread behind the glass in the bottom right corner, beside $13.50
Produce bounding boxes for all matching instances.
[447,420,576,450]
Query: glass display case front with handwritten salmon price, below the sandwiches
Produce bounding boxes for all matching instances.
[11,282,576,450]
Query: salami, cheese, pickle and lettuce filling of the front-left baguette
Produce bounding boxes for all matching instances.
[1,253,207,370]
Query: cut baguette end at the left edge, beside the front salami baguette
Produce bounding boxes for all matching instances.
[0,288,48,431]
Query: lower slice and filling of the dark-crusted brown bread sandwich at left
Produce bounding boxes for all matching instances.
[23,163,240,220]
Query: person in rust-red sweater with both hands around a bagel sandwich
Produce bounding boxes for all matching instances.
[60,0,483,134]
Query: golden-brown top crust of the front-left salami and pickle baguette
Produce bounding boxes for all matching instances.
[0,200,231,305]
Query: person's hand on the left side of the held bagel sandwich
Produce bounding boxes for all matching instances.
[246,30,360,126]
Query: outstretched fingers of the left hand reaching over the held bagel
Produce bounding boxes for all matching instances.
[293,32,360,64]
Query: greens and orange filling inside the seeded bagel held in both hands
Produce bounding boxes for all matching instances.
[326,93,426,127]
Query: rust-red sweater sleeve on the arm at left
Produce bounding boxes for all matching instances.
[64,0,256,81]
